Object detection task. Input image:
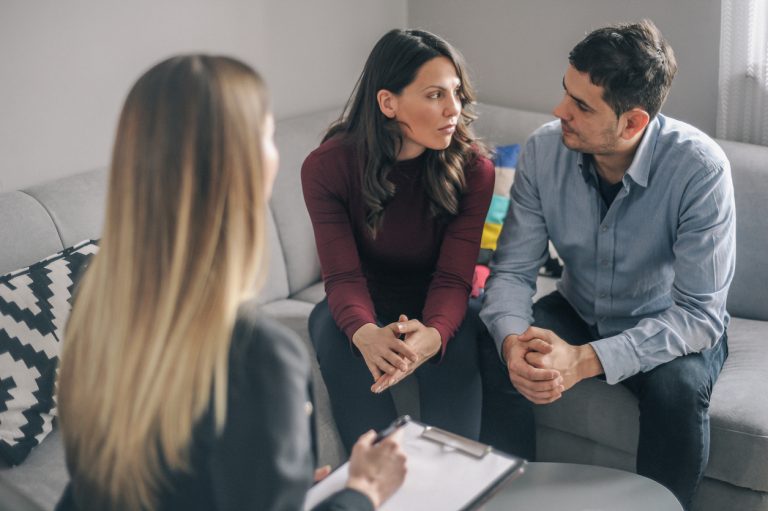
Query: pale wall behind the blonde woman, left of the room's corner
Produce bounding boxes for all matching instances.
[0,0,407,191]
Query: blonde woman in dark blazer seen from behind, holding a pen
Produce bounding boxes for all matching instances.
[58,55,405,510]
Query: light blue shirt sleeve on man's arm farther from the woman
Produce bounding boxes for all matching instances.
[591,160,736,383]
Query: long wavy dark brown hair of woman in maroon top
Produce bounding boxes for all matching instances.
[323,29,485,237]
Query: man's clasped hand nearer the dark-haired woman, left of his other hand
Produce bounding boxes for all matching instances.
[502,334,563,404]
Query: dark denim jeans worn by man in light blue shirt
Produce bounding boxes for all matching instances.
[480,291,728,509]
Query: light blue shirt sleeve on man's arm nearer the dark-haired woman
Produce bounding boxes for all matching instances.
[480,137,549,360]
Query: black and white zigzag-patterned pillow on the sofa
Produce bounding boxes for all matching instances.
[0,240,98,465]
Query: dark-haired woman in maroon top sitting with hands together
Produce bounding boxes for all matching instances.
[302,30,494,448]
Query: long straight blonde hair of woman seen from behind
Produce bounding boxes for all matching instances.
[58,55,268,509]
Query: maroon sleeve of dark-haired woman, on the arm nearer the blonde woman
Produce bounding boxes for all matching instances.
[301,153,376,340]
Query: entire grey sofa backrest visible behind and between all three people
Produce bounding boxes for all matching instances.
[0,104,768,320]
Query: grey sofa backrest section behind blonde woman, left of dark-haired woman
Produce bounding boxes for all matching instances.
[0,108,339,302]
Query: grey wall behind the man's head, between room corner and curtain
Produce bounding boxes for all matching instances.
[408,0,720,134]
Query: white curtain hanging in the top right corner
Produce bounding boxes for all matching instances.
[717,0,768,145]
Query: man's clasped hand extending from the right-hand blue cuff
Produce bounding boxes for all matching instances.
[518,326,603,392]
